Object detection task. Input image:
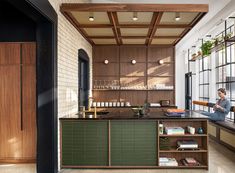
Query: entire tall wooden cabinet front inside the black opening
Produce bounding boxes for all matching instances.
[0,43,36,162]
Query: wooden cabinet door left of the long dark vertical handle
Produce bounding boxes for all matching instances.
[0,43,22,160]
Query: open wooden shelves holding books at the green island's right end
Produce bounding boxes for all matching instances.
[158,120,208,169]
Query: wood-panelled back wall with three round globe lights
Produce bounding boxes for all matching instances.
[93,45,175,105]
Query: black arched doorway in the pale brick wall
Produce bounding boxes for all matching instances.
[78,49,90,109]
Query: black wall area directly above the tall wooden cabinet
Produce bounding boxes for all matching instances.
[0,1,36,42]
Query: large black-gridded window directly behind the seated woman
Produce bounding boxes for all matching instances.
[215,22,235,121]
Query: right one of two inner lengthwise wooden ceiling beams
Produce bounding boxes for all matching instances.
[145,12,163,45]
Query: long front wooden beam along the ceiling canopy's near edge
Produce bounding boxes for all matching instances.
[60,3,208,12]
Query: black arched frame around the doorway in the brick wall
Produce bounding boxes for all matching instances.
[78,49,90,108]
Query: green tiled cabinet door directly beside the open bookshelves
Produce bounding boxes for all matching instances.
[111,120,157,166]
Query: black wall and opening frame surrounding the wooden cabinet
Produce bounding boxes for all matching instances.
[0,0,58,173]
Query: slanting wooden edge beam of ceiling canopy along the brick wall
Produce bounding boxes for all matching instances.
[62,12,95,45]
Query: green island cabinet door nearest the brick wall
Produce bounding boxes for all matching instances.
[62,121,108,166]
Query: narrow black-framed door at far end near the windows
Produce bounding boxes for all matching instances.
[185,72,192,110]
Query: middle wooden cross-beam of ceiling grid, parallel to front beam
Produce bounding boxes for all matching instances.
[79,24,192,28]
